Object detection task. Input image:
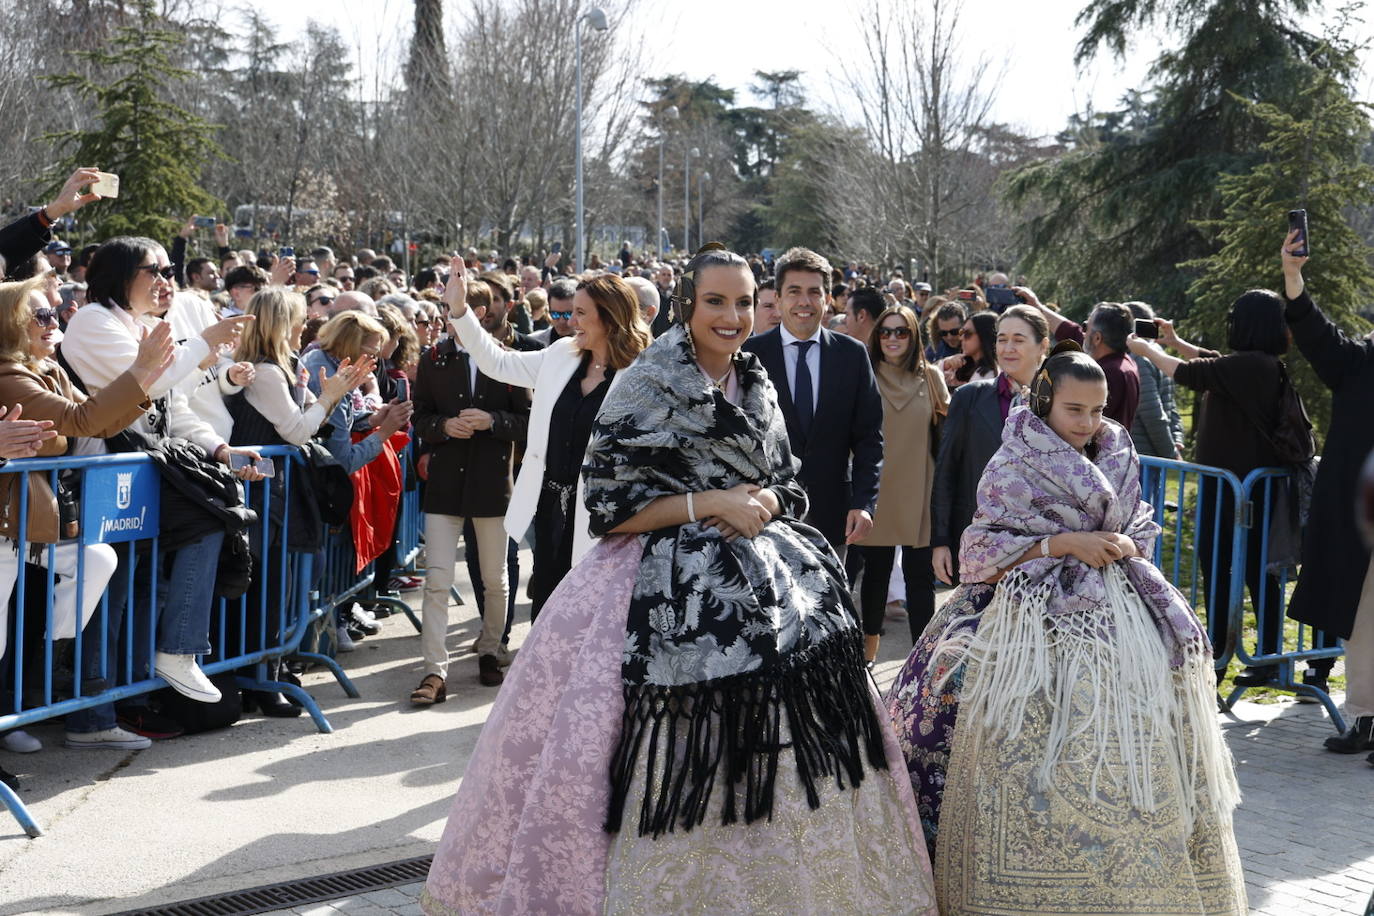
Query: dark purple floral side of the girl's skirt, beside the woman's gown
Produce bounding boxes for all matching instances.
[886,584,995,861]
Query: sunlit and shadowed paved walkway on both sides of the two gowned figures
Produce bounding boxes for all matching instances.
[0,551,1374,916]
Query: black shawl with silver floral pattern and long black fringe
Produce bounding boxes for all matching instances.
[583,327,886,836]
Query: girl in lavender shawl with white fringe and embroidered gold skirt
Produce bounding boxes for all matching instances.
[888,345,1246,916]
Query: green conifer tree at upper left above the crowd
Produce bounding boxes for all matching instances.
[48,0,224,239]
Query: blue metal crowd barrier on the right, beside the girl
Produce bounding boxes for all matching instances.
[1140,456,1345,731]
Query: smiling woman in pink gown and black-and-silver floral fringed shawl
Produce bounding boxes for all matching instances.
[425,249,934,916]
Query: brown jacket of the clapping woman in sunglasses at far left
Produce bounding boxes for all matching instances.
[0,361,148,542]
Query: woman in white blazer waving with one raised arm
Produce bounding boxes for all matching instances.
[444,269,653,619]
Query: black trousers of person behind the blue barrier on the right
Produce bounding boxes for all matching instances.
[1194,478,1283,658]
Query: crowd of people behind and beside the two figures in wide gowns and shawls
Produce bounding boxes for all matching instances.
[0,169,1374,791]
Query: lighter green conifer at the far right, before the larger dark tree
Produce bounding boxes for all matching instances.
[1183,26,1374,439]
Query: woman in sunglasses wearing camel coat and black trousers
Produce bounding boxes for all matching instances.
[849,295,949,662]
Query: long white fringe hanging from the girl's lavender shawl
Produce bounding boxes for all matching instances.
[932,564,1239,824]
